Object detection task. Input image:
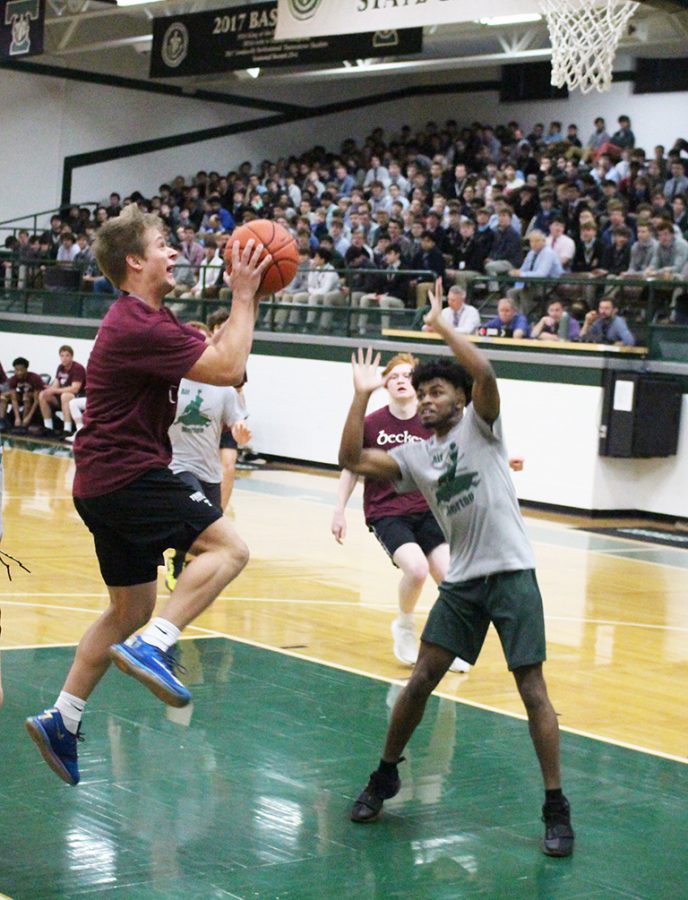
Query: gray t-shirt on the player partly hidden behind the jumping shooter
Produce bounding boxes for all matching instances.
[169,378,246,484]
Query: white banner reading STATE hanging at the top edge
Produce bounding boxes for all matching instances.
[275,0,541,40]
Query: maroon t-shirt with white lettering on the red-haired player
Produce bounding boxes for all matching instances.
[363,406,432,522]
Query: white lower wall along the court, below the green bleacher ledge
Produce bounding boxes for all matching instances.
[0,332,688,517]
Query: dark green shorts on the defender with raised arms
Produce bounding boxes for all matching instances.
[422,569,547,672]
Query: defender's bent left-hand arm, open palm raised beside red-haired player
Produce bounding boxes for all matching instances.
[339,347,401,481]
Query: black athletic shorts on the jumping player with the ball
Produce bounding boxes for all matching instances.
[74,469,222,587]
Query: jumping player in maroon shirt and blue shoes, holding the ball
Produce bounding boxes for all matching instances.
[26,204,272,784]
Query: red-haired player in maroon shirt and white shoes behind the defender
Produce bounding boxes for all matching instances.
[331,353,470,672]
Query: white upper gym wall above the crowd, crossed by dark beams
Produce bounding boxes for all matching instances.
[0,68,688,220]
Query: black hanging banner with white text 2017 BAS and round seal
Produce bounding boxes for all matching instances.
[150,3,423,78]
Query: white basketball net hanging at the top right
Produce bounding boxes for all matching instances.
[540,0,639,94]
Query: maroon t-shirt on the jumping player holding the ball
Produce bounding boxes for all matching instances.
[74,296,205,497]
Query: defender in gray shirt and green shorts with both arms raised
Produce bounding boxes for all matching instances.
[339,281,574,856]
